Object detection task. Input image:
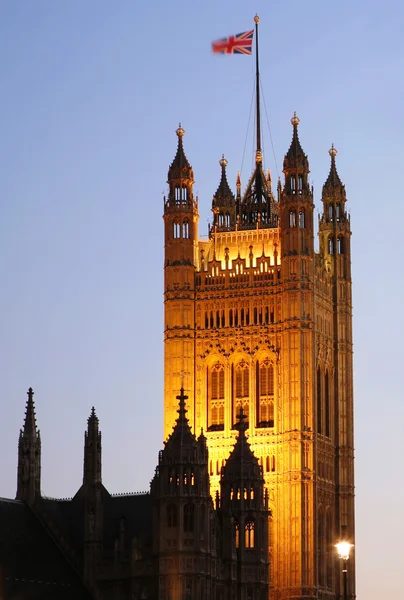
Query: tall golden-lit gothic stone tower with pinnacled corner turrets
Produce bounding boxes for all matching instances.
[164,115,355,600]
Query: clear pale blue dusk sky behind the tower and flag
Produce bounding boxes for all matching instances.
[0,0,404,600]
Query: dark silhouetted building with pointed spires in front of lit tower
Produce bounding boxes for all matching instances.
[0,388,269,600]
